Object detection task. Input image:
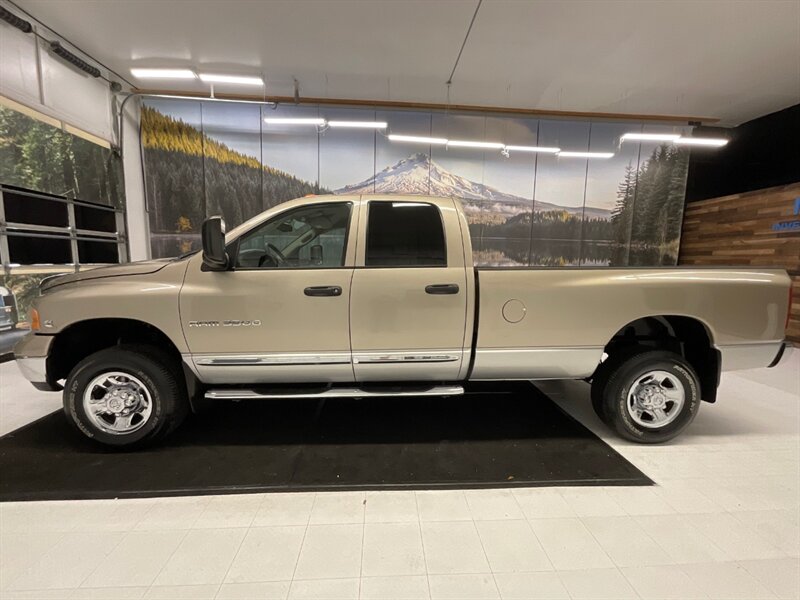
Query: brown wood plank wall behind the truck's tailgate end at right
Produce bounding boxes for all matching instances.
[678,182,800,344]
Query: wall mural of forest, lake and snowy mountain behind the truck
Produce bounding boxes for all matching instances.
[142,98,690,266]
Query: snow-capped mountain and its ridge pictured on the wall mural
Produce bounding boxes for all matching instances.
[335,152,611,220]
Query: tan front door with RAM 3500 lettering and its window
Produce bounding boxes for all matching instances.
[180,202,358,383]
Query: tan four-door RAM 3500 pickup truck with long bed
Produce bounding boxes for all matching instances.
[15,195,790,446]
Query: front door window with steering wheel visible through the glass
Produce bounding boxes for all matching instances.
[236,202,351,269]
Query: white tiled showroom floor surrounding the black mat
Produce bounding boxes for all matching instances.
[0,352,800,600]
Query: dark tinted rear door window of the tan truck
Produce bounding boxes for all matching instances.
[366,202,447,267]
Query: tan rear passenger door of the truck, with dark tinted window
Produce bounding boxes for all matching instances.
[350,199,470,381]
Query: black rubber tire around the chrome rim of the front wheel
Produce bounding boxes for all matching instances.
[64,345,189,448]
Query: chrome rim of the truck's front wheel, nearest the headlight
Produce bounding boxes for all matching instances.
[83,371,153,435]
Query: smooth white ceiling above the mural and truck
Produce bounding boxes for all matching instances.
[9,0,800,125]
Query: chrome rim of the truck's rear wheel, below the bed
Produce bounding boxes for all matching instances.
[627,371,686,429]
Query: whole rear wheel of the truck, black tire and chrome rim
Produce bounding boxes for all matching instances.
[593,349,700,444]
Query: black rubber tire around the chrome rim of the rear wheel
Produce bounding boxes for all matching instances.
[593,349,701,444]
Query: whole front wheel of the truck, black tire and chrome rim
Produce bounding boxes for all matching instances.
[64,345,189,448]
